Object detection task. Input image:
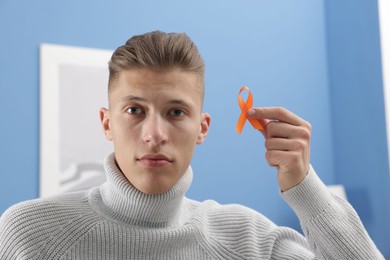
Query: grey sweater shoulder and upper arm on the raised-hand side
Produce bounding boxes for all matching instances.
[184,200,307,259]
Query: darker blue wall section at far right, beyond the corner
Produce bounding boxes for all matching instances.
[326,1,390,256]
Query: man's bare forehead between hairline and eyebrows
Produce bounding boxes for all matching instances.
[109,69,203,105]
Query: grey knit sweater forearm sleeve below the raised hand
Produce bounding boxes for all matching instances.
[282,166,384,259]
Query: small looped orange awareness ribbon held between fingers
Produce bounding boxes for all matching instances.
[236,86,264,134]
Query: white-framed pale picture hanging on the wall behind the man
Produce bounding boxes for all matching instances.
[40,44,113,197]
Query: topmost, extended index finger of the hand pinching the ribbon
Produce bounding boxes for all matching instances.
[248,107,307,126]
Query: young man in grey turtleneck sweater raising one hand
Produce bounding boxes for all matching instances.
[0,31,383,259]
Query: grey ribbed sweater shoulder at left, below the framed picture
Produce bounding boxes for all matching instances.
[0,192,96,258]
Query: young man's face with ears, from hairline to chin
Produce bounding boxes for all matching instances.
[100,69,210,194]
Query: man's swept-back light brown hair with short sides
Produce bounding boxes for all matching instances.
[108,31,205,94]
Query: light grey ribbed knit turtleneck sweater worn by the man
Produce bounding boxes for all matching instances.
[0,155,384,260]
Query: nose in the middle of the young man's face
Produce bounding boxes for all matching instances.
[142,115,168,145]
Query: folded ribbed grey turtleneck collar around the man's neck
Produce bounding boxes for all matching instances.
[92,154,192,228]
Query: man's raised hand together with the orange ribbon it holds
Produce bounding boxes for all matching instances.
[236,86,311,191]
